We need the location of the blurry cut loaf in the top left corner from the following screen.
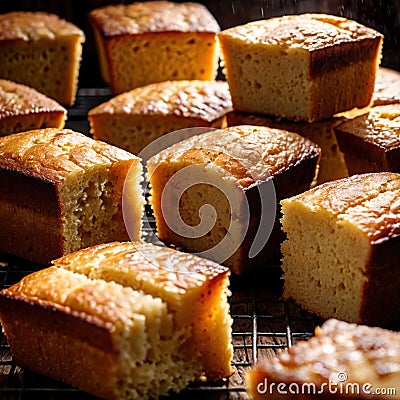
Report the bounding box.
[0,12,85,106]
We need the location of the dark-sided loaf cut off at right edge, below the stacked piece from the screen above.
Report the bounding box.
[335,103,400,174]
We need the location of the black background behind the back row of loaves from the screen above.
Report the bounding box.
[0,0,400,87]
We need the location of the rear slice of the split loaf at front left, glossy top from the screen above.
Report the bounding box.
[54,242,233,380]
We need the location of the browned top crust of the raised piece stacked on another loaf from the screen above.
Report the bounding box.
[220,14,382,51]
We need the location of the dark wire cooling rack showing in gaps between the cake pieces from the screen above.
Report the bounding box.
[0,89,322,400]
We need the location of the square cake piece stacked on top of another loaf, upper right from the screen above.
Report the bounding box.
[219,14,382,122]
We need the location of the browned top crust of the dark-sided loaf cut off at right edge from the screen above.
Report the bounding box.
[336,103,400,151]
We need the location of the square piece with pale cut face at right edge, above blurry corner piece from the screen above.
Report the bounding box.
[281,172,400,325]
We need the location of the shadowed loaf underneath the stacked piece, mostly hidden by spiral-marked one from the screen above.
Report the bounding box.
[226,111,349,185]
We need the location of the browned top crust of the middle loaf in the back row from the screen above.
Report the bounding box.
[89,1,220,37]
